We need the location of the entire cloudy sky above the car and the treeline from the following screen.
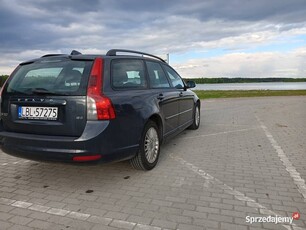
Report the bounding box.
[0,0,306,78]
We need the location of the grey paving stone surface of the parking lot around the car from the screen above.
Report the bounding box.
[0,97,306,230]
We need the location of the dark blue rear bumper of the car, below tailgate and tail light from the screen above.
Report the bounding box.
[0,121,138,162]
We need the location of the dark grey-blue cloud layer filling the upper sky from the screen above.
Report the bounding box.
[0,0,306,75]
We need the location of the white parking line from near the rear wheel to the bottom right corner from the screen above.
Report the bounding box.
[170,153,302,230]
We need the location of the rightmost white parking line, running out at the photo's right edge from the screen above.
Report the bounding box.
[255,115,306,202]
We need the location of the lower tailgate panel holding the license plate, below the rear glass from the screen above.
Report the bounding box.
[2,96,86,136]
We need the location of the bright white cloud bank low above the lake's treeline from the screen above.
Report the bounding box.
[173,48,306,78]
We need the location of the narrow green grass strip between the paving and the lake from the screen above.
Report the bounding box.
[194,90,306,99]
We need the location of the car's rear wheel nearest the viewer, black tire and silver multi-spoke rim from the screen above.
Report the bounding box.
[130,120,161,170]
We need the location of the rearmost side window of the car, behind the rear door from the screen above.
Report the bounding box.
[111,59,147,89]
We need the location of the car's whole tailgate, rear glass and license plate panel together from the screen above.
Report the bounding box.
[1,57,92,137]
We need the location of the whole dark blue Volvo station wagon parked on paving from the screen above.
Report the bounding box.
[0,49,200,170]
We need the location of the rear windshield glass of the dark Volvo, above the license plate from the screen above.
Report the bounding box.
[6,59,92,95]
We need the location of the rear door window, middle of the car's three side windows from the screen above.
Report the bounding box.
[146,61,170,88]
